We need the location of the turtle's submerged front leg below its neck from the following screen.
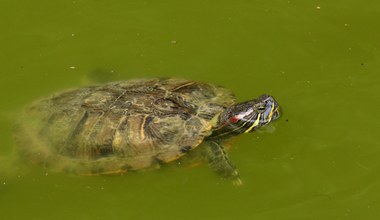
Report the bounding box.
[203,140,242,185]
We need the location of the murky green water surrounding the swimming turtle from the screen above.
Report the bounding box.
[0,0,380,220]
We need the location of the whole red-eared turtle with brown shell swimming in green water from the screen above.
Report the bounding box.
[18,78,280,184]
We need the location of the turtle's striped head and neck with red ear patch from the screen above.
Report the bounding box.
[211,94,280,137]
